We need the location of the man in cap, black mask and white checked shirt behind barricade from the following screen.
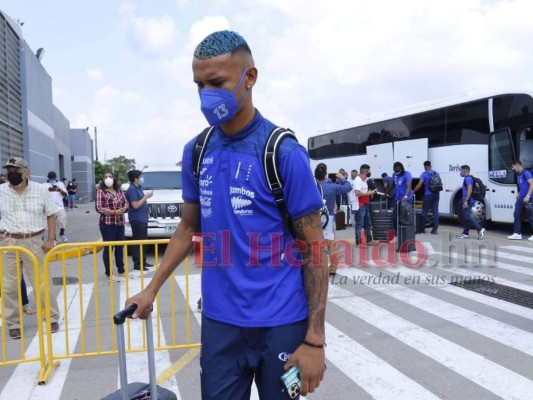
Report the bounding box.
[0,157,59,339]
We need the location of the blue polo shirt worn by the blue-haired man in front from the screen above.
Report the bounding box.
[182,111,323,327]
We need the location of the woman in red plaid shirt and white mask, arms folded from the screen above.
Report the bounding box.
[95,172,128,280]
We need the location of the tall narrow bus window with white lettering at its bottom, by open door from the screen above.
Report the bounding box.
[489,128,514,184]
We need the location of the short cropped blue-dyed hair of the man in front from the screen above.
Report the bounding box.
[194,31,252,60]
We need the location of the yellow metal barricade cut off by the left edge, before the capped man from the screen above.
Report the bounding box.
[0,246,46,376]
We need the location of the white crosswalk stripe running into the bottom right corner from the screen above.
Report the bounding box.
[330,286,533,399]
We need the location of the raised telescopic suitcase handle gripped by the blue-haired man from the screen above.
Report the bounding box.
[113,304,157,400]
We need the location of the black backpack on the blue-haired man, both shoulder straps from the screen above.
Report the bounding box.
[192,126,298,236]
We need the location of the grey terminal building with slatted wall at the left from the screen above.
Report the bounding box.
[0,10,94,202]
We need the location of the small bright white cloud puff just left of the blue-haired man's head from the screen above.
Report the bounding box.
[120,5,179,54]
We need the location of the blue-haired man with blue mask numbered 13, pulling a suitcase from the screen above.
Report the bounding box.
[127,31,328,400]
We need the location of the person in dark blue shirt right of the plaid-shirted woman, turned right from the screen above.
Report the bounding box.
[126,169,153,271]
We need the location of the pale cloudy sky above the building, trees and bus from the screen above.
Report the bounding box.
[0,0,533,168]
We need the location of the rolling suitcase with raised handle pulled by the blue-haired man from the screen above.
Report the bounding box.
[102,304,177,400]
